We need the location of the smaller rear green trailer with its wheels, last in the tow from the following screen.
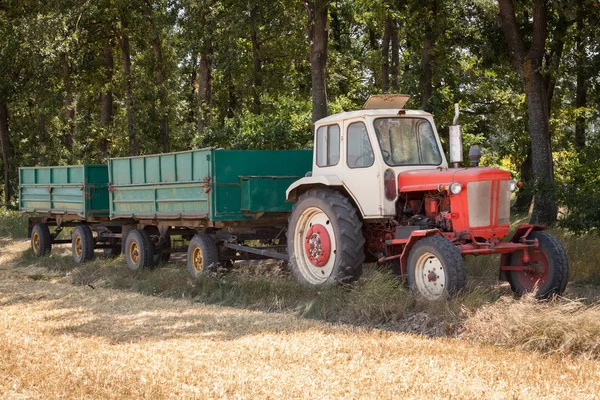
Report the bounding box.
[19,164,121,262]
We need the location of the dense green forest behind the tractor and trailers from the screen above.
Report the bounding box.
[0,0,600,232]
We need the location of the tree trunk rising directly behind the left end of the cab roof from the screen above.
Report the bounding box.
[304,0,329,122]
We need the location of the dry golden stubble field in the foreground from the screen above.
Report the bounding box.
[0,239,600,399]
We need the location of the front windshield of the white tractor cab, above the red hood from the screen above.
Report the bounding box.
[373,117,442,166]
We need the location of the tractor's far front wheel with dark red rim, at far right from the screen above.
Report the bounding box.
[507,231,569,298]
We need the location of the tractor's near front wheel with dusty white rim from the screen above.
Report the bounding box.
[407,236,467,300]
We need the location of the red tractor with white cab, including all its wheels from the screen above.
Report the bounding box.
[286,95,569,300]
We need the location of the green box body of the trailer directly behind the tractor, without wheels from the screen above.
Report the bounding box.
[108,149,312,223]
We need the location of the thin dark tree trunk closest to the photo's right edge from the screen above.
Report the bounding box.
[575,0,587,149]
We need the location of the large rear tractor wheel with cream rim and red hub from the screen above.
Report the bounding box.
[287,189,365,286]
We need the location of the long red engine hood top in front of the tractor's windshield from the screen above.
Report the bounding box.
[398,167,510,192]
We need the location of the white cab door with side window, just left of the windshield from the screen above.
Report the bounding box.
[340,119,383,218]
